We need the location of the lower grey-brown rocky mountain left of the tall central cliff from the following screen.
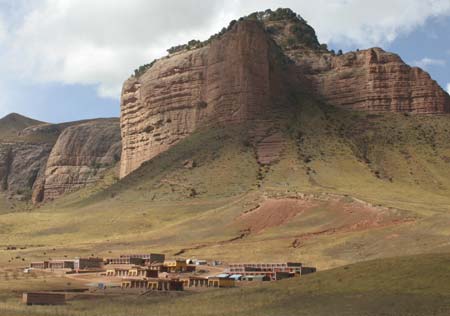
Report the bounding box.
[0,114,121,203]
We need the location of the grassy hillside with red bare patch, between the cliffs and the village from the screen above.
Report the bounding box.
[0,97,450,269]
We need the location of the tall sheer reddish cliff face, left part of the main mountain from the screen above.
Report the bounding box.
[121,21,288,177]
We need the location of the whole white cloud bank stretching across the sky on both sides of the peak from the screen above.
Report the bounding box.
[0,0,450,98]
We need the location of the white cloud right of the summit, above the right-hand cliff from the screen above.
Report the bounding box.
[234,0,450,47]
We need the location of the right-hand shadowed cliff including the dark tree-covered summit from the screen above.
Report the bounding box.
[262,11,450,114]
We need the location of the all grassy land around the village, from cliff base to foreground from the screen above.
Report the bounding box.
[0,100,450,316]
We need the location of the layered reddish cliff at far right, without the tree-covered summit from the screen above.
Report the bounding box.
[295,48,450,114]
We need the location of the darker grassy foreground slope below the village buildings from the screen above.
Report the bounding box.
[0,254,450,316]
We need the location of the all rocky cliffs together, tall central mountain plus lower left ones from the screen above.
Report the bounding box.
[0,9,450,202]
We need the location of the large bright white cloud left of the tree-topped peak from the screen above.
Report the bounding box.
[4,0,236,97]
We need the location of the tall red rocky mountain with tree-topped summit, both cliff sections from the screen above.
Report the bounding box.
[120,9,450,177]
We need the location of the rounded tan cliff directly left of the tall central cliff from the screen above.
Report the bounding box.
[38,119,121,202]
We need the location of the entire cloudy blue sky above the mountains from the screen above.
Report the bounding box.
[0,0,450,122]
